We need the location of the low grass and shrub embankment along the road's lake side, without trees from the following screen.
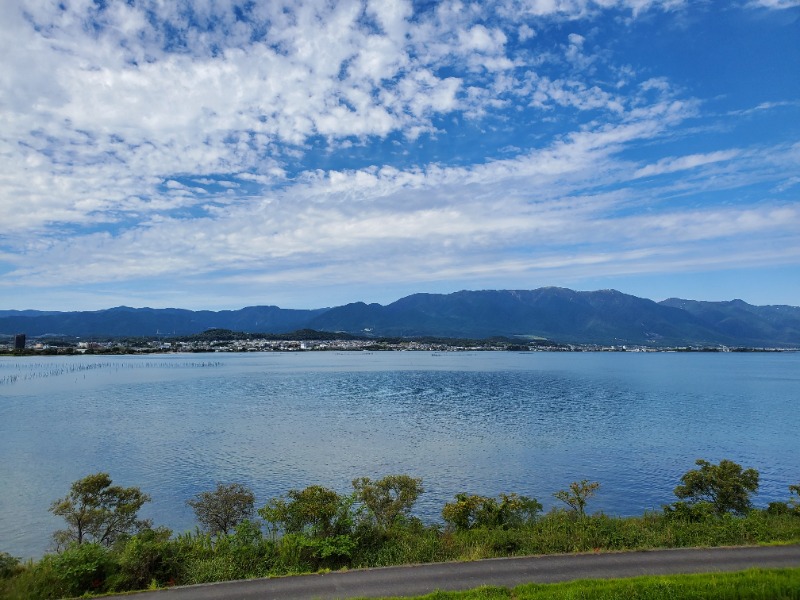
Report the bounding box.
[0,509,800,599]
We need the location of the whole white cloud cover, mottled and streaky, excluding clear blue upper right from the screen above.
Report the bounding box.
[0,0,800,310]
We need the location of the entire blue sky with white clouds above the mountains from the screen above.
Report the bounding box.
[0,0,800,310]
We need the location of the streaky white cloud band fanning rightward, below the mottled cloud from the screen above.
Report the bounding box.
[4,103,800,296]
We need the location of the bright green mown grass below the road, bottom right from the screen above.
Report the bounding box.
[366,568,800,600]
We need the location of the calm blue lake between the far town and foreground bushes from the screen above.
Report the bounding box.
[0,352,800,557]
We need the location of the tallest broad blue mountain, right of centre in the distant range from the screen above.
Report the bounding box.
[310,287,732,345]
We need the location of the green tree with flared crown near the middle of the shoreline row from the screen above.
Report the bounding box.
[353,475,425,529]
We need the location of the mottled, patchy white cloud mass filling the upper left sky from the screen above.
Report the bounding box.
[0,0,668,241]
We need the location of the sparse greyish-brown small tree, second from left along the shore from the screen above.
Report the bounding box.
[186,483,256,535]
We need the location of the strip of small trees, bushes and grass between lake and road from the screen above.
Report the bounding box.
[0,460,800,599]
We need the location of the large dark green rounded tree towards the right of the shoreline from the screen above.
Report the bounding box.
[675,459,758,514]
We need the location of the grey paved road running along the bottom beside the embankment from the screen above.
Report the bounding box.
[114,545,800,600]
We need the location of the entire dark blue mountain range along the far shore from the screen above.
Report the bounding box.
[0,287,800,347]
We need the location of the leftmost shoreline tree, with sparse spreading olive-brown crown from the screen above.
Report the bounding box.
[50,473,150,548]
